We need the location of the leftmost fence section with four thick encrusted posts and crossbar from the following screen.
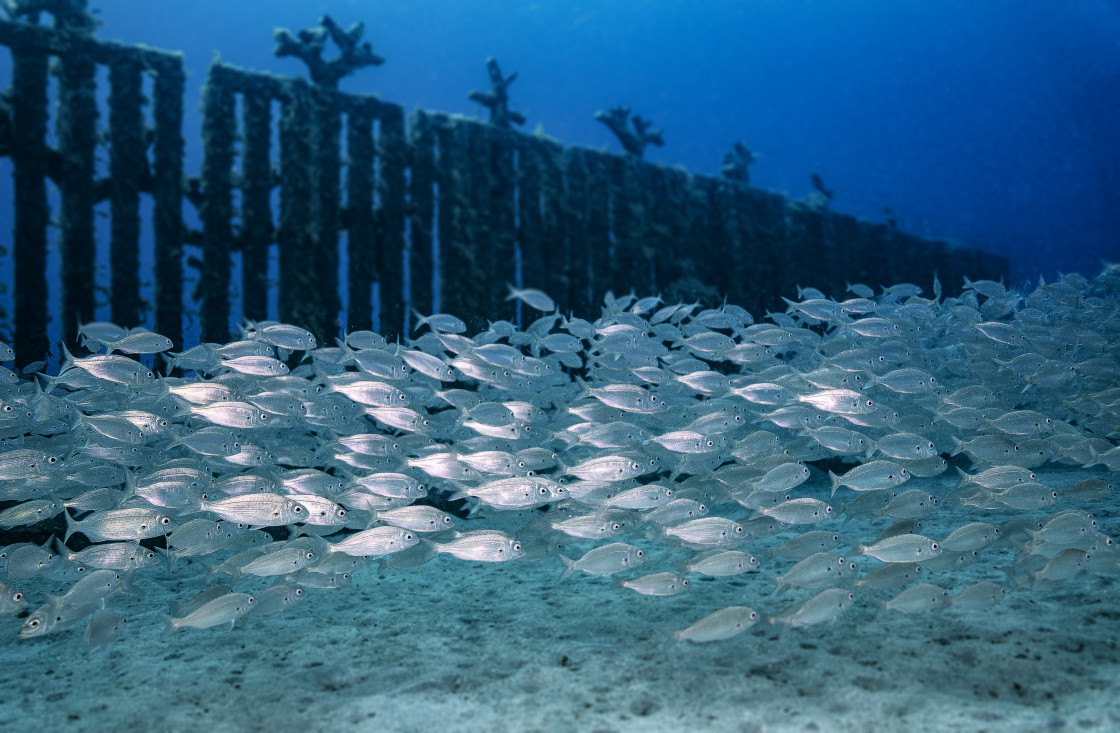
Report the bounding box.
[0,21,186,361]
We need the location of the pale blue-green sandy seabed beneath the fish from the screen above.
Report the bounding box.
[0,470,1120,733]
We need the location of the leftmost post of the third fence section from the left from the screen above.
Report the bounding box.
[409,110,436,322]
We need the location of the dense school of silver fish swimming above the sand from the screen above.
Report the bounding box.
[0,271,1120,649]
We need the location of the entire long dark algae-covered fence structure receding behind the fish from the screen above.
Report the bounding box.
[0,21,1008,363]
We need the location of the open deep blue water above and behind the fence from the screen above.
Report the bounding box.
[0,0,1120,289]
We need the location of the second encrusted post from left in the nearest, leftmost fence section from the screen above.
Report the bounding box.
[56,47,97,344]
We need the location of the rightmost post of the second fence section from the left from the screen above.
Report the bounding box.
[377,104,409,338]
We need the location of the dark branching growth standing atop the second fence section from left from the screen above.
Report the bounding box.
[272,16,385,89]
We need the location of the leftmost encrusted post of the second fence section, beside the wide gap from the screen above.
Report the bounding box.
[200,64,236,343]
